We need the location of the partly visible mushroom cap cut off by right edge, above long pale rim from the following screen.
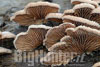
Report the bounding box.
[90,7,100,24]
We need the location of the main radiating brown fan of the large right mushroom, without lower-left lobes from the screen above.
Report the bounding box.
[60,26,100,54]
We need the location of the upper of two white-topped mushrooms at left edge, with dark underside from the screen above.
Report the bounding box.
[0,31,16,48]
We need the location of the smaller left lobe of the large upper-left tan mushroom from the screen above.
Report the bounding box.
[11,10,39,26]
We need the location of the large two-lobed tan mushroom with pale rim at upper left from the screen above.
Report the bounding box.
[11,2,60,26]
